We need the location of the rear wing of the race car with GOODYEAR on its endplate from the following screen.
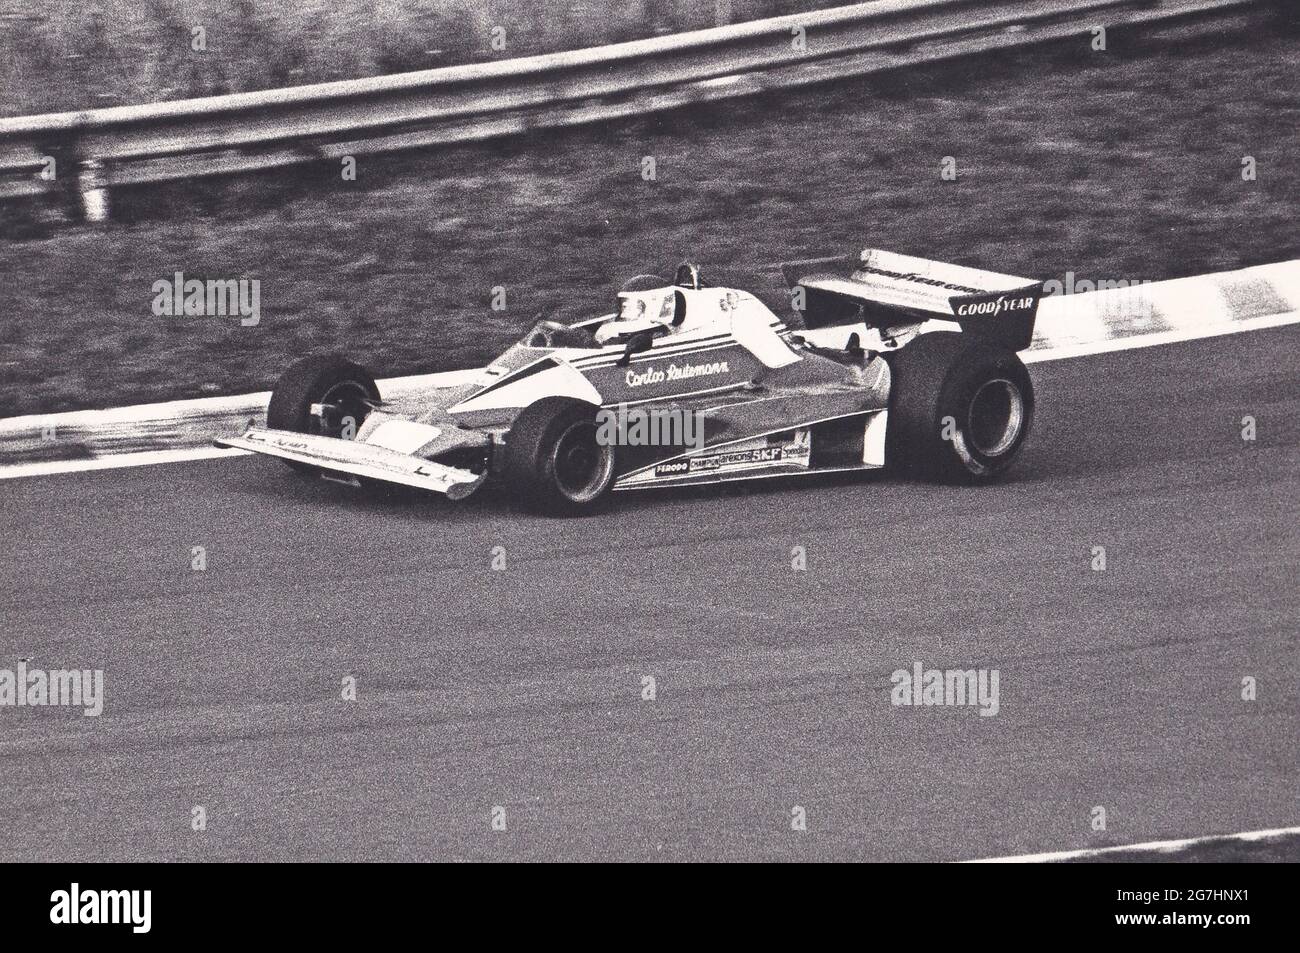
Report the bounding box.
[781,248,1043,351]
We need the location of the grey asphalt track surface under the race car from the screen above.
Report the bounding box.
[0,328,1300,861]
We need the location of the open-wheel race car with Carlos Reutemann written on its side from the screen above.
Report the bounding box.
[215,250,1043,514]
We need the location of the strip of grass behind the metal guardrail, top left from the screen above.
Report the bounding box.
[0,0,840,116]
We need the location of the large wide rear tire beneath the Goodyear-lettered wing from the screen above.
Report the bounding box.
[885,332,1034,484]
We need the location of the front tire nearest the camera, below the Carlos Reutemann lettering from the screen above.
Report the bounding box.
[501,397,615,516]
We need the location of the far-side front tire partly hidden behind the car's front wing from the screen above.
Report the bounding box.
[267,354,380,473]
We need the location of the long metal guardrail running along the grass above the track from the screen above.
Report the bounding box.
[0,0,1261,220]
